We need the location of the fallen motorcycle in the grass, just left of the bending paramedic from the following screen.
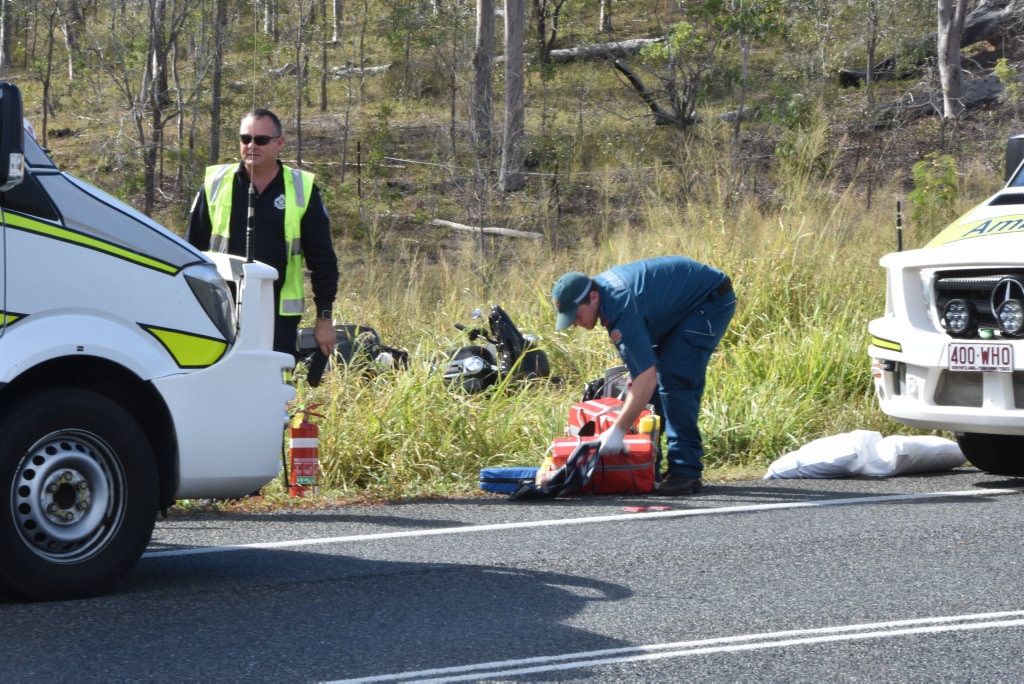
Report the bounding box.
[435,304,557,393]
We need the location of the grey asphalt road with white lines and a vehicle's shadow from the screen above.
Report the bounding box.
[0,468,1024,682]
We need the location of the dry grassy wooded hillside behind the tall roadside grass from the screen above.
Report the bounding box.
[8,0,1021,250]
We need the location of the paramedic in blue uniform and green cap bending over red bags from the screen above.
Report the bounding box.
[551,257,736,496]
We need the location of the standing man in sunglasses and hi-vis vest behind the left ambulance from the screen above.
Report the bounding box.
[185,110,338,356]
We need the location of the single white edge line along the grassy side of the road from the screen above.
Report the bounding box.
[142,487,1024,558]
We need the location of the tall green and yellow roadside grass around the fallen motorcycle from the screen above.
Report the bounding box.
[258,167,921,501]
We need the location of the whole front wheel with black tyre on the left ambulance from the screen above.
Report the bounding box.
[0,388,158,600]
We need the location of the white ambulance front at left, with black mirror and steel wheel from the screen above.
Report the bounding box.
[0,83,295,600]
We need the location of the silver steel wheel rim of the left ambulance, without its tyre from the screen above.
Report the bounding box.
[10,430,125,563]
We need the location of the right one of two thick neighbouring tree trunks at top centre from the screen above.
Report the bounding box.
[498,0,526,193]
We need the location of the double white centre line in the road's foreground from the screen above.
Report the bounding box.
[335,610,1024,684]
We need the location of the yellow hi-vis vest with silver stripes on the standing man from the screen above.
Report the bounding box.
[199,164,313,315]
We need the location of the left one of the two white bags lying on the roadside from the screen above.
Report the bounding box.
[764,430,882,480]
